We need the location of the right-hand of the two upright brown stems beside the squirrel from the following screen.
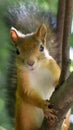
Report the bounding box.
[60,0,73,84]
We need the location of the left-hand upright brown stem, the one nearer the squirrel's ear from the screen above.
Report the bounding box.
[56,0,66,66]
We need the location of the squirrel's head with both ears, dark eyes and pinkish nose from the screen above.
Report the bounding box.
[10,24,48,70]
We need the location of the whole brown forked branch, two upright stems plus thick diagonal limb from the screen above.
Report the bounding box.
[42,0,73,130]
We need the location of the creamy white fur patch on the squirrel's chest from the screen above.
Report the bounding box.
[29,68,55,100]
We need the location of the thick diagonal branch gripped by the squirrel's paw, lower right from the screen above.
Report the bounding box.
[48,72,73,130]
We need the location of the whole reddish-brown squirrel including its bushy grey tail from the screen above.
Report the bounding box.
[6,1,70,130]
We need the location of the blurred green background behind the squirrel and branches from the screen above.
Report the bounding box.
[0,0,73,130]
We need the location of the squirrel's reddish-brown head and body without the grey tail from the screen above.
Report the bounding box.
[10,24,60,130]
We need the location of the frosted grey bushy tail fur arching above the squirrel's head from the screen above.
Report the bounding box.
[5,2,56,33]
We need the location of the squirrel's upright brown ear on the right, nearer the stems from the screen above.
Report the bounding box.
[36,24,47,41]
